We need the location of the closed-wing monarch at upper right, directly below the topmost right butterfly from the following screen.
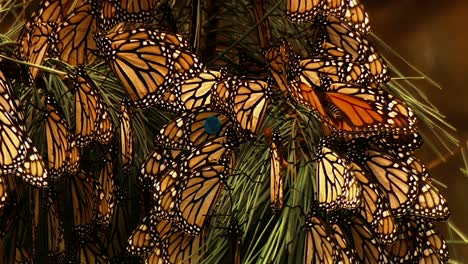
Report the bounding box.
[314,15,390,83]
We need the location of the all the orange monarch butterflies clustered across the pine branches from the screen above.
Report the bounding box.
[0,0,449,263]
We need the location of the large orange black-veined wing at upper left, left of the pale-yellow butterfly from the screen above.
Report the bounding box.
[96,28,174,107]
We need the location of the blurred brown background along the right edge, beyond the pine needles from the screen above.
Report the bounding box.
[363,0,468,263]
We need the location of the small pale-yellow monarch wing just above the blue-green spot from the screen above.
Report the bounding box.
[158,71,221,113]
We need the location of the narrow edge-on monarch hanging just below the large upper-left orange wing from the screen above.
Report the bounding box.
[119,99,134,172]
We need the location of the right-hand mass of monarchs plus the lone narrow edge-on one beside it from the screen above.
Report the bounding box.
[264,0,450,263]
